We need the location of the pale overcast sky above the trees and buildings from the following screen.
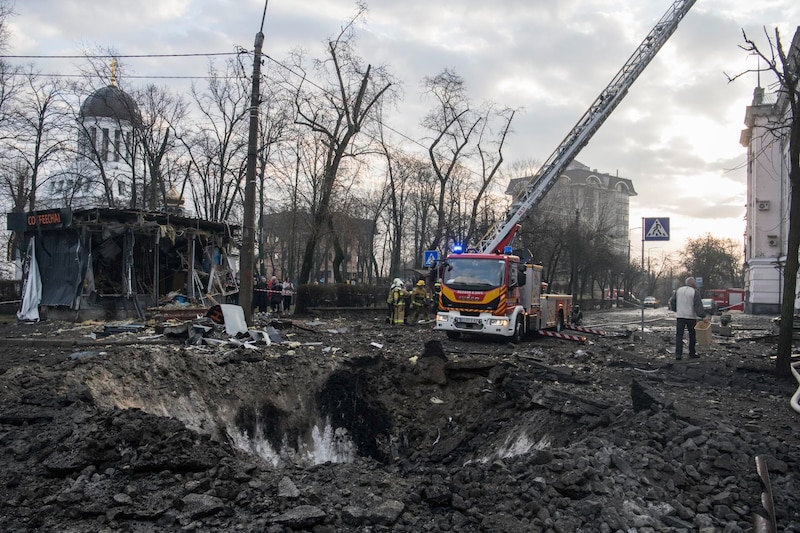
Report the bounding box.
[7,0,800,256]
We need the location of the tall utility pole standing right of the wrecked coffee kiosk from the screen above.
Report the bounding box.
[239,0,269,326]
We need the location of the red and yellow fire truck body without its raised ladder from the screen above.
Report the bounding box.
[434,253,572,342]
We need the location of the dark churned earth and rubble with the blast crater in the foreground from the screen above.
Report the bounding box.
[0,313,800,533]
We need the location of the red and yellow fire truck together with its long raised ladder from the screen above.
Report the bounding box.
[434,0,696,340]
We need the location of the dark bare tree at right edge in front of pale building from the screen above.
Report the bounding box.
[728,27,800,377]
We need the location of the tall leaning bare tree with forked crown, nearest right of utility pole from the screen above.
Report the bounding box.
[295,6,392,283]
